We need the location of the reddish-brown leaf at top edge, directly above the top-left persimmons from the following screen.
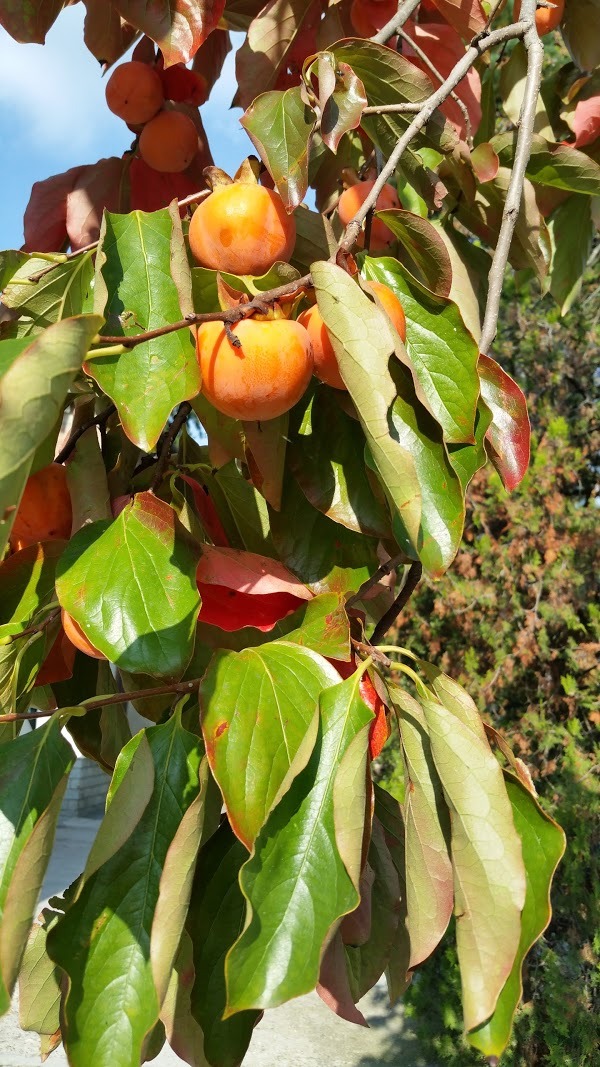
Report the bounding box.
[113,0,225,66]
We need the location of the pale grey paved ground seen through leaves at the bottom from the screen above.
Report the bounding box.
[0,818,432,1067]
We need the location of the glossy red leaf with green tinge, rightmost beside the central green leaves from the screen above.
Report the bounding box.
[477,355,531,492]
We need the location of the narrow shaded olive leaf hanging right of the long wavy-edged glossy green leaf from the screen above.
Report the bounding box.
[345,818,400,1003]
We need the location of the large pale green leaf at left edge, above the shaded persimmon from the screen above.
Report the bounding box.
[0,315,102,553]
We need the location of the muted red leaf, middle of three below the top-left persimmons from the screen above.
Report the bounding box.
[66,156,130,250]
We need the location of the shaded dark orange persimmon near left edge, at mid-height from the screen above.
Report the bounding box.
[10,463,73,552]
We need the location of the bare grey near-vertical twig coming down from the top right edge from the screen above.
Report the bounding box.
[479,0,543,354]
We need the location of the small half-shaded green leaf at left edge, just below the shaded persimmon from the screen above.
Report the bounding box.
[0,541,64,635]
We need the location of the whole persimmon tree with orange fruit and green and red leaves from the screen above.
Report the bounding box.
[0,0,600,1067]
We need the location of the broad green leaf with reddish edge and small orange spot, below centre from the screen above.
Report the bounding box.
[200,641,340,849]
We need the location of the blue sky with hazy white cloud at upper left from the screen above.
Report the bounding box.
[0,4,248,249]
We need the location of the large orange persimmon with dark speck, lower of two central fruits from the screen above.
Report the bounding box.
[198,319,313,421]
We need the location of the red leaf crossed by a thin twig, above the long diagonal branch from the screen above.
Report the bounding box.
[404,21,481,137]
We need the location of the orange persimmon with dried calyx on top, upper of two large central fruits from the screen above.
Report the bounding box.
[190,181,296,275]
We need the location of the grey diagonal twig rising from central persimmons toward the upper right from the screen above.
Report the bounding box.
[340,21,533,252]
